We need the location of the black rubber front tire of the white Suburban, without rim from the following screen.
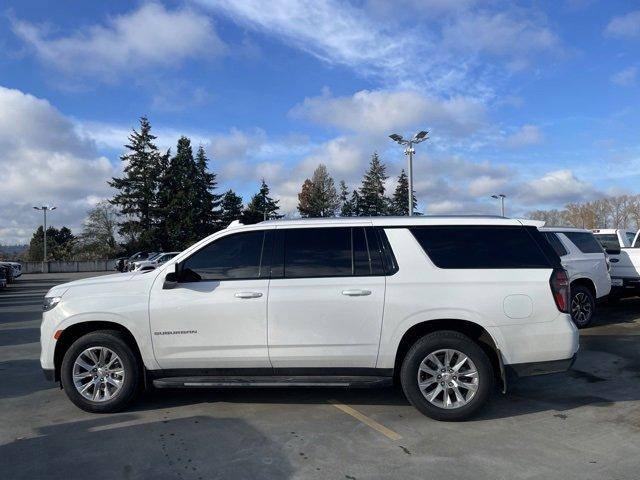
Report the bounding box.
[60,330,141,413]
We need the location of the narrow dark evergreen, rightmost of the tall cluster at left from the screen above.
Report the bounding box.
[193,145,221,238]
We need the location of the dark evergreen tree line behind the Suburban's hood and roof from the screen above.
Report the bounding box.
[25,117,417,261]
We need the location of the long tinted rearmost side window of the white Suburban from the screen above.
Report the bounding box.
[410,225,553,269]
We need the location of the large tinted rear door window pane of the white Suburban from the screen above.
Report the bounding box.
[284,228,353,278]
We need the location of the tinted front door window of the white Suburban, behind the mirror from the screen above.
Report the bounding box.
[181,231,266,281]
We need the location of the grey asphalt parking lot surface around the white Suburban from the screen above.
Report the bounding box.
[0,274,640,480]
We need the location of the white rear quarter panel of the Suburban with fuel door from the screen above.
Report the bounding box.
[378,228,567,368]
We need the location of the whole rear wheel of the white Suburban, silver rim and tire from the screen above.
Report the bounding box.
[400,331,494,421]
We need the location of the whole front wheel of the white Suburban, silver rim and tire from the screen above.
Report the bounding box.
[60,330,140,413]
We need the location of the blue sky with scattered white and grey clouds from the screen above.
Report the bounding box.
[0,0,640,244]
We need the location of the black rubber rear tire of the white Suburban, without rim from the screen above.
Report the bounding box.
[400,330,494,421]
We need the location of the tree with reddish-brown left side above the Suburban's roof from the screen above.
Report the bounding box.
[298,164,340,217]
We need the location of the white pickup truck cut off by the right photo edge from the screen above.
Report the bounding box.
[593,228,640,300]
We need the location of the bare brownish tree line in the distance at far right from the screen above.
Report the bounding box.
[527,195,640,230]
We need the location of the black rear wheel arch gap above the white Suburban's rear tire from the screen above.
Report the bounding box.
[393,318,506,391]
